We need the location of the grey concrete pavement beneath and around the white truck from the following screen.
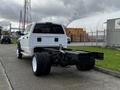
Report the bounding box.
[0,45,120,90]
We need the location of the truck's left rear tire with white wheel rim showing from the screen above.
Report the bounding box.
[32,52,51,76]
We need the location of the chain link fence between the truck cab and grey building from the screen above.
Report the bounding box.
[70,30,106,46]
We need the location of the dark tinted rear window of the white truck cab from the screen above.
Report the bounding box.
[33,24,64,34]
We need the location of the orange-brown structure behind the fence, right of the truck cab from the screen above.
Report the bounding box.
[65,28,89,42]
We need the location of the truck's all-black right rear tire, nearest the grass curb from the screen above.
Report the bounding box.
[76,58,95,71]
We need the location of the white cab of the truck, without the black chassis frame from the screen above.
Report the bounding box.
[18,23,67,56]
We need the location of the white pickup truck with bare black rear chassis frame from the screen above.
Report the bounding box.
[17,23,103,76]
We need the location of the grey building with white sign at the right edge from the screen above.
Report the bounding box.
[106,18,120,47]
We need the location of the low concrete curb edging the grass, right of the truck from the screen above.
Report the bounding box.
[94,66,120,78]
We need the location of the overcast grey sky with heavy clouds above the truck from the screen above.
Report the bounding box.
[0,0,120,25]
